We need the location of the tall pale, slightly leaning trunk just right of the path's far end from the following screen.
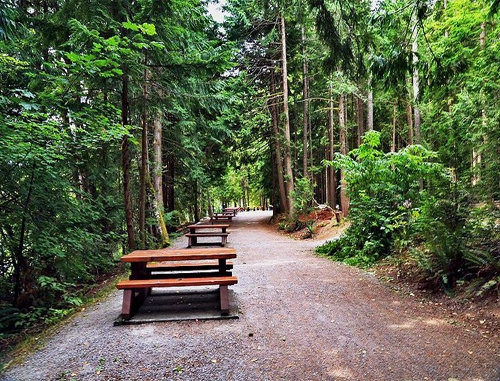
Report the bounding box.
[280,14,295,218]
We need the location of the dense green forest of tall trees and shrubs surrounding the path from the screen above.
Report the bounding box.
[0,0,500,338]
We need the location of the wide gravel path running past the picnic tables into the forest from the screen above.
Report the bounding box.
[0,212,500,381]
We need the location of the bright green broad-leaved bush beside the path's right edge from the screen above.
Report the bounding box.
[318,132,443,265]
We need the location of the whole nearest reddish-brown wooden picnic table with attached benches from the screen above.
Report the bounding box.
[116,248,238,319]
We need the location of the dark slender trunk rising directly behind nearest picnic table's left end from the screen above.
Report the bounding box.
[121,68,136,250]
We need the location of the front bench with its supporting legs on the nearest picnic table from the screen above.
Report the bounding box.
[116,276,238,319]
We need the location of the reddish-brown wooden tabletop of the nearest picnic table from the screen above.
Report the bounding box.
[120,247,236,262]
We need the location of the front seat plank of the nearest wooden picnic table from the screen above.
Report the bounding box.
[116,276,238,290]
